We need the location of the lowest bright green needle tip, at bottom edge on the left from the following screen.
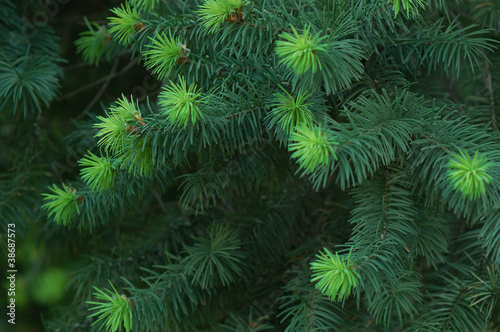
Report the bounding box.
[85,281,133,332]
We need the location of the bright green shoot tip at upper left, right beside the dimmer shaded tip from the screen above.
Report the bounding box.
[108,4,143,45]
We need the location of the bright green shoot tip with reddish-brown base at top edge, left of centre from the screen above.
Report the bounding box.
[198,0,246,33]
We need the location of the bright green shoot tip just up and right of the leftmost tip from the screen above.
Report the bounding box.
[78,151,116,192]
